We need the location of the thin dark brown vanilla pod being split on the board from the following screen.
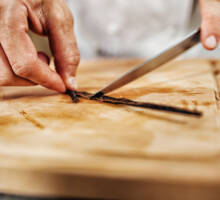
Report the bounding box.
[67,91,202,117]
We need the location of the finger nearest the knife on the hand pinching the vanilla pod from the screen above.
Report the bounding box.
[47,4,80,90]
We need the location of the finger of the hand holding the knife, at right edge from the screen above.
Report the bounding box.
[200,0,220,50]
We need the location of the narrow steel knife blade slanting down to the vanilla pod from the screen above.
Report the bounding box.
[91,29,201,99]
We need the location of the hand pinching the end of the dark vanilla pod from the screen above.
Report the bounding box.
[0,0,80,92]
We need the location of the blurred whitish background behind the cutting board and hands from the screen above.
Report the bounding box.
[30,0,220,59]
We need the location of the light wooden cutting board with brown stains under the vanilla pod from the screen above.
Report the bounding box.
[0,60,220,200]
